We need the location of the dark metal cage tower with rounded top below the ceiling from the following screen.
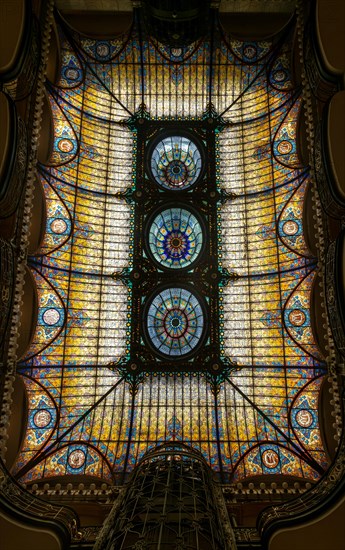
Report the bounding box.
[96,442,235,550]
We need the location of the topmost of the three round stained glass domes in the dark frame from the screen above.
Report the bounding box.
[150,135,202,191]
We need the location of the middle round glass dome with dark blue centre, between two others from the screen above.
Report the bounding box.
[148,207,204,269]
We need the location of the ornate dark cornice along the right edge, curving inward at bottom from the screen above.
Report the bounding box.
[257,0,345,546]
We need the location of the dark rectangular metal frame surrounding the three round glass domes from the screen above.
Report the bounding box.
[114,112,233,380]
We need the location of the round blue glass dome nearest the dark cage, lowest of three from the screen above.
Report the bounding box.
[146,287,205,358]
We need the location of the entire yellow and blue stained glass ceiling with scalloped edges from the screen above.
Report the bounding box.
[14,12,328,483]
